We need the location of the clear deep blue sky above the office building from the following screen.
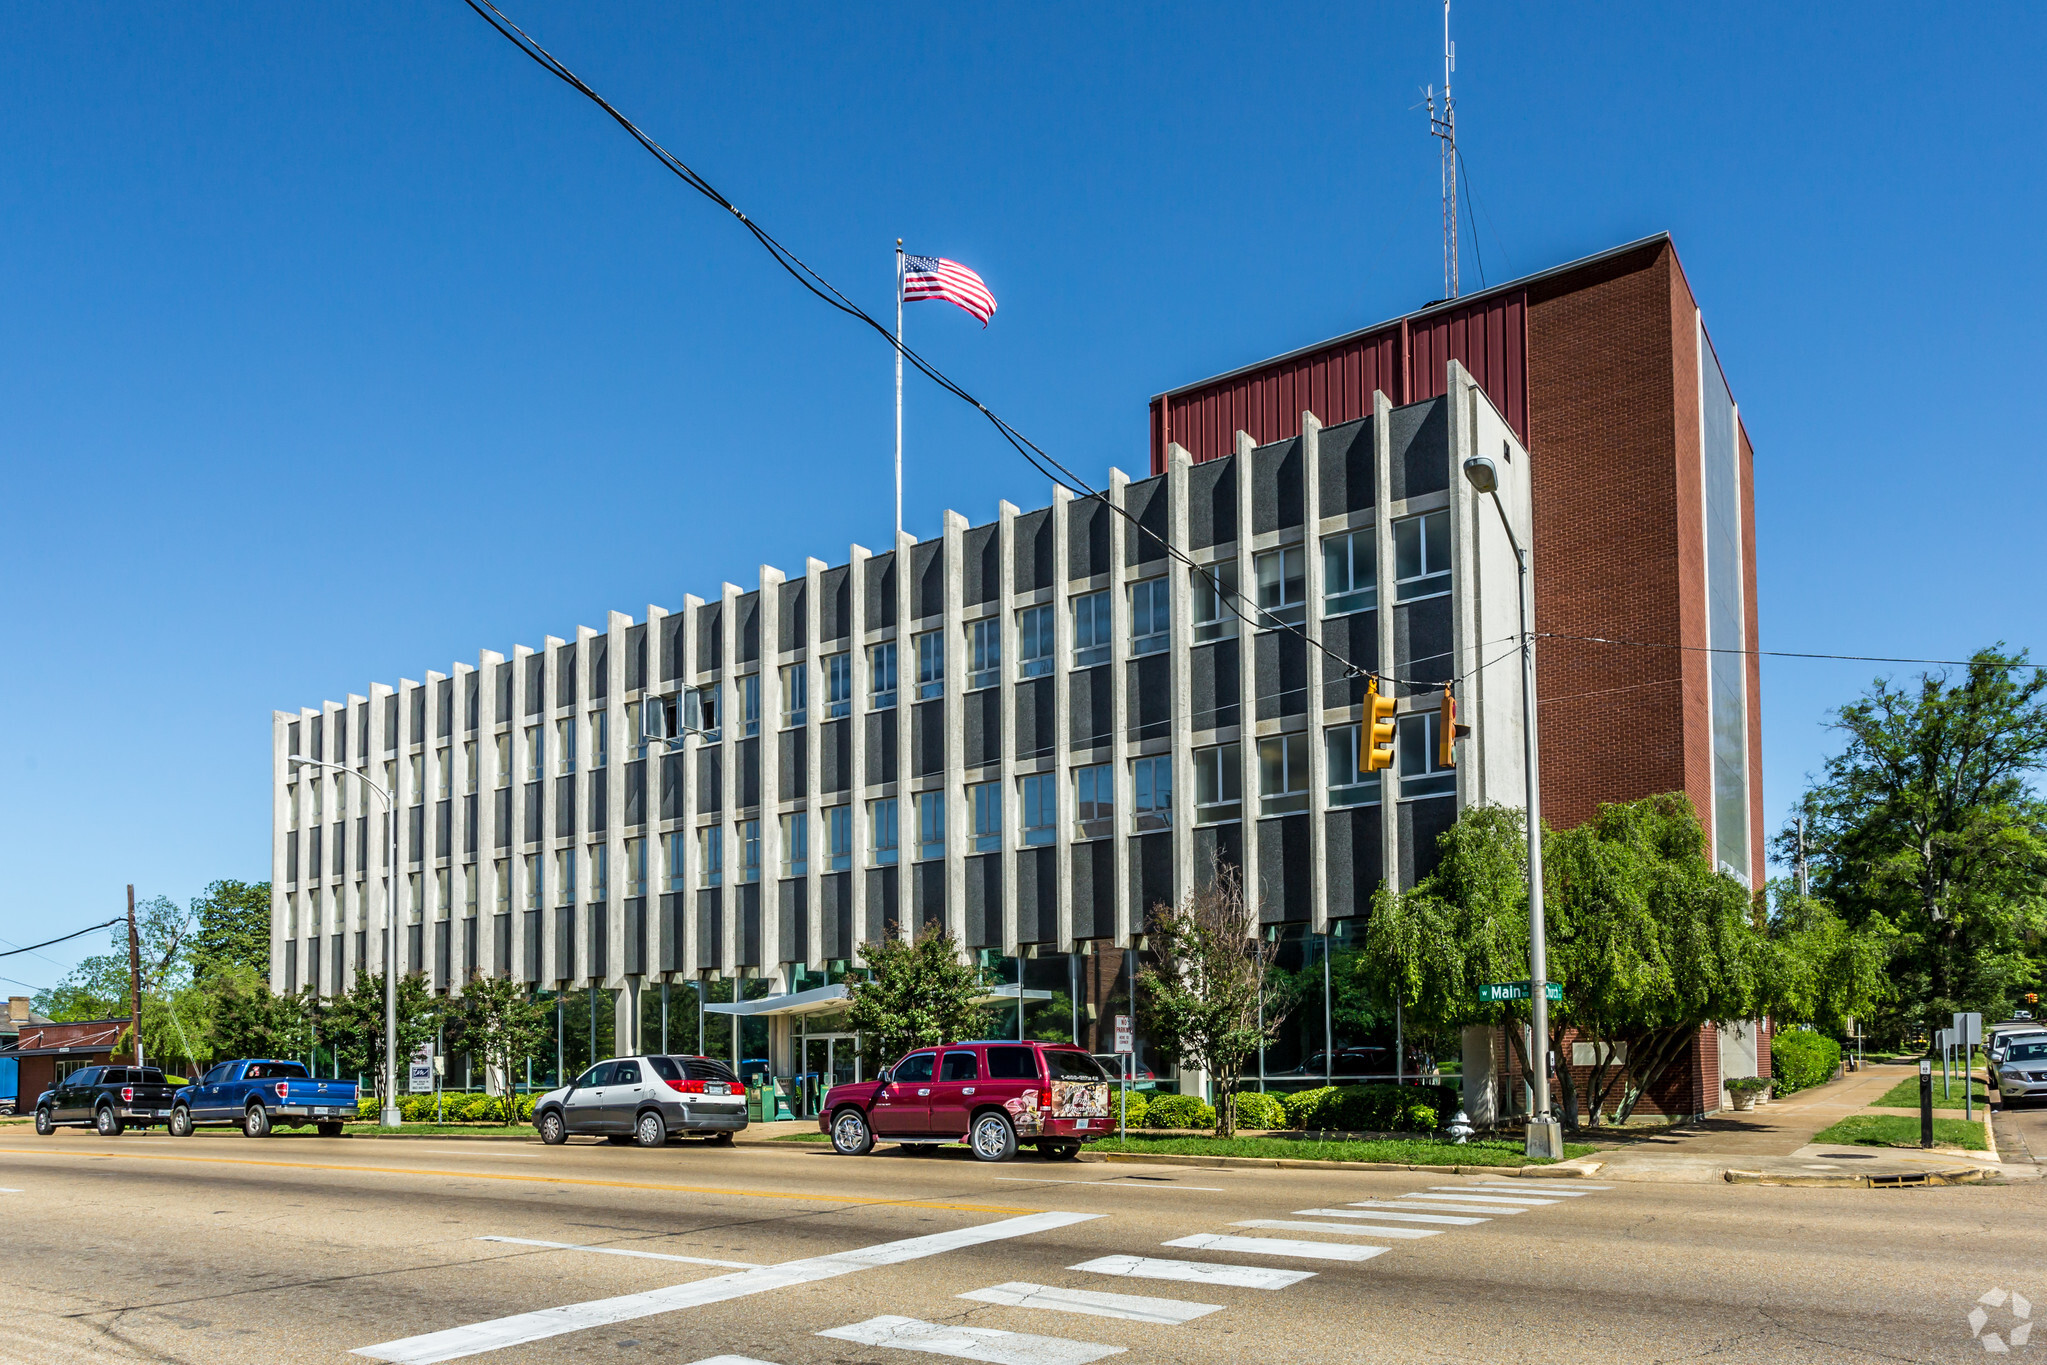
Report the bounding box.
[0,0,2047,993]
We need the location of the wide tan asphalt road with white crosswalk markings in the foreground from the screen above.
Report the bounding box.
[0,1128,2047,1365]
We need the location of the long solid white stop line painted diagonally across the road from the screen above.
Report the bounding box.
[354,1214,1101,1365]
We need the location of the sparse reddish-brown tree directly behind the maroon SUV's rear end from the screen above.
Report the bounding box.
[1138,860,1306,1138]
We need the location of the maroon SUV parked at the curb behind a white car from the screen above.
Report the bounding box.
[817,1042,1114,1160]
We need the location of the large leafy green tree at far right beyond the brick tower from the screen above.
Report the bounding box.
[1777,645,2047,1038]
